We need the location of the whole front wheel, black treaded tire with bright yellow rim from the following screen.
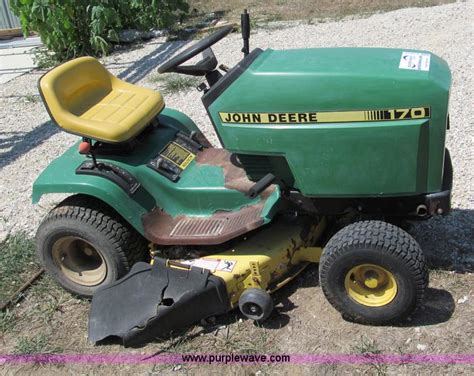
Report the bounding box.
[319,221,428,325]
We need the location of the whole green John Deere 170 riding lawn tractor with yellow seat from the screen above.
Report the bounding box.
[33,13,452,346]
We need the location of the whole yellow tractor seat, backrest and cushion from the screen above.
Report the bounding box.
[39,57,165,143]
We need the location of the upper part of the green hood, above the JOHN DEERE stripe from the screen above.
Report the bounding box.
[213,48,451,112]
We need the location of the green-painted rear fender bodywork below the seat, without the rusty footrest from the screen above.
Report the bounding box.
[32,108,274,235]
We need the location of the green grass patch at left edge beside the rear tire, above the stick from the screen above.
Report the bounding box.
[0,233,39,302]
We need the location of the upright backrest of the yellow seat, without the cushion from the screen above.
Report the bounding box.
[38,56,112,119]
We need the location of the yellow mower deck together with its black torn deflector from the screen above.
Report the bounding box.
[89,217,325,346]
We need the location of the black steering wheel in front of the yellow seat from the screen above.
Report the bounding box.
[158,25,234,76]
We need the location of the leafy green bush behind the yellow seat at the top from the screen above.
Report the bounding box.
[10,0,188,61]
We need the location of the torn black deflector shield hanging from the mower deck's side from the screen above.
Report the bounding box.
[89,259,229,347]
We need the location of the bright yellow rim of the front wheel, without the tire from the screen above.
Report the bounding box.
[344,264,398,307]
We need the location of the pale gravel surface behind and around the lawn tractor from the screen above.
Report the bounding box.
[0,1,474,269]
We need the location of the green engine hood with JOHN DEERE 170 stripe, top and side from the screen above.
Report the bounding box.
[208,48,451,197]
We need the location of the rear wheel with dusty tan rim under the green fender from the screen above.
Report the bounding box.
[36,195,146,297]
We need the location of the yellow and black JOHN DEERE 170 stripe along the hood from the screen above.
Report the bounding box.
[219,107,431,124]
